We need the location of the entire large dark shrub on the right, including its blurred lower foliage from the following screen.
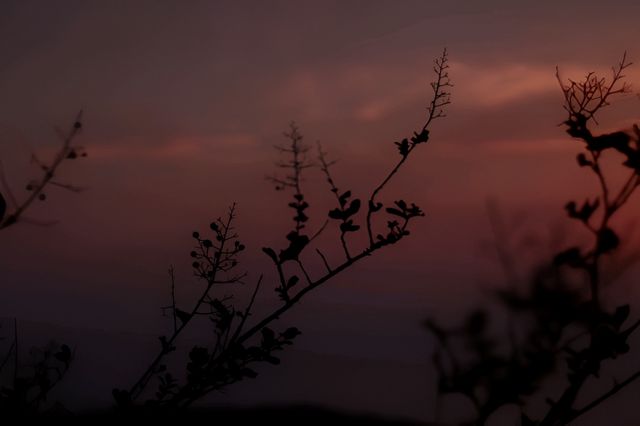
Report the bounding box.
[425,54,640,426]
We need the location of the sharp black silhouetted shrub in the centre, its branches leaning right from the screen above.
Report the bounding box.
[113,50,451,409]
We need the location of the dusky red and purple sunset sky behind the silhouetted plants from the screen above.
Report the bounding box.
[0,0,640,420]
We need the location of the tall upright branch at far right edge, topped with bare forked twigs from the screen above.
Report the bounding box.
[540,53,640,426]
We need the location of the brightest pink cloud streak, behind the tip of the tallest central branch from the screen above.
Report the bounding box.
[273,56,640,122]
